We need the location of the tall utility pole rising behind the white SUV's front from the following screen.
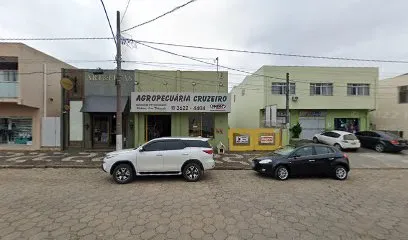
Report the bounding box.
[115,11,123,150]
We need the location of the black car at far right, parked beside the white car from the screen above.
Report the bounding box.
[356,131,408,152]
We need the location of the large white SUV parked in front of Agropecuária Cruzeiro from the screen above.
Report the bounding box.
[102,137,215,184]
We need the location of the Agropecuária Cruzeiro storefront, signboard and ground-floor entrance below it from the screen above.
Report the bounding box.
[130,92,231,147]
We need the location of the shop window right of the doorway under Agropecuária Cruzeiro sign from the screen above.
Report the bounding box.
[188,113,214,138]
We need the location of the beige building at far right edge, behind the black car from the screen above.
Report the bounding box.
[371,74,408,138]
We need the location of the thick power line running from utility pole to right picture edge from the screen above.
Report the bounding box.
[127,39,408,64]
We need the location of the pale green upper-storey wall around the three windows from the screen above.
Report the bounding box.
[262,66,378,109]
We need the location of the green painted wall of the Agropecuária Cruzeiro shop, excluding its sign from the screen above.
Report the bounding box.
[134,70,228,147]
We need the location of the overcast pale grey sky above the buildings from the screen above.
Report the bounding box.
[0,0,408,87]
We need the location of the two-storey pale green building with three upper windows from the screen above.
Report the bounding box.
[229,66,378,139]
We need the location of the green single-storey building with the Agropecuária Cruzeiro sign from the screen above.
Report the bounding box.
[129,70,231,149]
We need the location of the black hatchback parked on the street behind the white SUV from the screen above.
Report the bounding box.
[252,144,350,180]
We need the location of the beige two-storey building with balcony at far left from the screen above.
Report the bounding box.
[0,43,73,150]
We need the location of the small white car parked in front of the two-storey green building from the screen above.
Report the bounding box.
[313,131,361,150]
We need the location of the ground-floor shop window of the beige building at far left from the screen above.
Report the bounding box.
[0,117,33,145]
